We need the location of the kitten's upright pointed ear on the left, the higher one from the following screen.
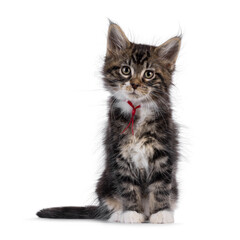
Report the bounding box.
[107,21,130,55]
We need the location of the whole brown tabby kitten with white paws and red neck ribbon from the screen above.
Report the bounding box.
[37,23,181,223]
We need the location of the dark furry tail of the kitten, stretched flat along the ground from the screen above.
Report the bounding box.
[37,206,111,219]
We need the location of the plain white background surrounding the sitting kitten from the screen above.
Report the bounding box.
[0,0,240,240]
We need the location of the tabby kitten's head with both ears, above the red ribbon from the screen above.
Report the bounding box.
[103,22,181,102]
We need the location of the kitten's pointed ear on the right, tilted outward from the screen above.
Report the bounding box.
[156,37,181,71]
